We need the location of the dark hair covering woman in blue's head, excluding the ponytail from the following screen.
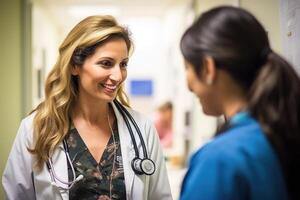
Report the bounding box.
[181,7,270,89]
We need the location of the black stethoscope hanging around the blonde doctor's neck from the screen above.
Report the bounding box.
[46,99,156,190]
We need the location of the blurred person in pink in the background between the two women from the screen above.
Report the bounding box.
[154,101,173,148]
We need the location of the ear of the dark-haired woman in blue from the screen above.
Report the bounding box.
[202,56,217,85]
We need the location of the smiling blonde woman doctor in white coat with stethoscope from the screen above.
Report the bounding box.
[2,16,172,200]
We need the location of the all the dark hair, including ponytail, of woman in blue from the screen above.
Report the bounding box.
[181,7,300,199]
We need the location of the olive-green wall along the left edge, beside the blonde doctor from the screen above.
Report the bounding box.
[0,0,22,199]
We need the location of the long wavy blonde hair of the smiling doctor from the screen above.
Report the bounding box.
[28,16,132,169]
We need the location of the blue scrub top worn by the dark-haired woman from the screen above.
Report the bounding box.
[180,112,288,200]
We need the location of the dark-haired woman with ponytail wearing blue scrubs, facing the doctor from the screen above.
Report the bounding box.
[180,6,300,200]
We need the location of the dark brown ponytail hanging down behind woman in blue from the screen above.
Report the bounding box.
[248,52,300,199]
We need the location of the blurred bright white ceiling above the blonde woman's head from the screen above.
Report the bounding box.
[32,0,191,35]
